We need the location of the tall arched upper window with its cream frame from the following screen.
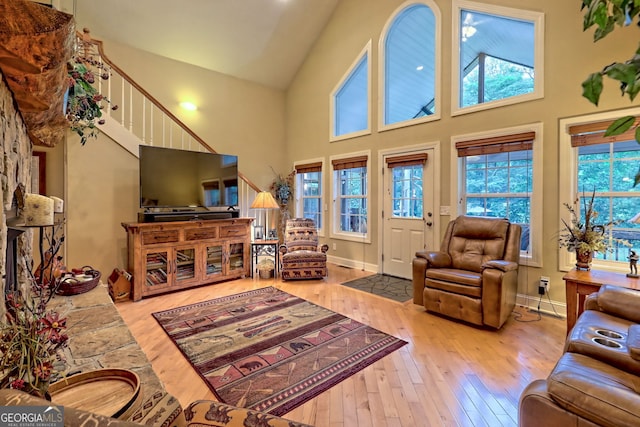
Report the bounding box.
[380,2,440,129]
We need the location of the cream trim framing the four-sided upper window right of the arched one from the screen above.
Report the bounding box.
[451,0,544,116]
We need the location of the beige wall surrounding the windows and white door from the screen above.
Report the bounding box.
[286,0,638,301]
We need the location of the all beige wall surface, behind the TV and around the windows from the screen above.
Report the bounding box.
[56,0,637,301]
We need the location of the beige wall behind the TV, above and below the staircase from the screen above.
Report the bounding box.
[61,41,288,280]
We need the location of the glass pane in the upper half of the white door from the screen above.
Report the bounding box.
[391,165,424,218]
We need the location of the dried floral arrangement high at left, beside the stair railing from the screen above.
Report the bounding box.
[66,28,118,145]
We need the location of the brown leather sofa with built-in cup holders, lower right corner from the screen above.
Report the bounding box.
[519,285,640,427]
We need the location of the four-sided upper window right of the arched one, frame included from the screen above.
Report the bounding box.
[453,0,543,114]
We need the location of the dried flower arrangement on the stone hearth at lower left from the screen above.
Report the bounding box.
[0,226,68,398]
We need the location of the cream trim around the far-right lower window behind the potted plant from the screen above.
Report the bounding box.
[554,107,640,273]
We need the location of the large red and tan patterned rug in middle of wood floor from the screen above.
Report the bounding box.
[153,287,406,416]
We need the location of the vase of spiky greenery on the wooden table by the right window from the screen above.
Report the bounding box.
[559,191,631,270]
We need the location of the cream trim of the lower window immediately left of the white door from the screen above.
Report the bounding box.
[325,150,373,243]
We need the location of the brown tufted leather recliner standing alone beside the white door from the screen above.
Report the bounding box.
[413,216,522,329]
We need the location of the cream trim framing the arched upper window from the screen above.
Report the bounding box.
[378,0,442,132]
